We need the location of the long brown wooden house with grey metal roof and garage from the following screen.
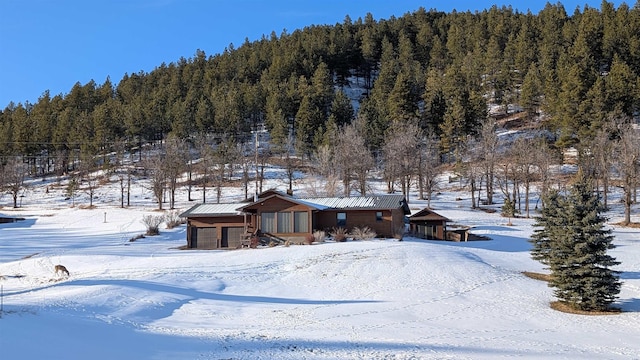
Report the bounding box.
[180,190,410,249]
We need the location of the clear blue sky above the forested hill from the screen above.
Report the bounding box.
[0,0,620,109]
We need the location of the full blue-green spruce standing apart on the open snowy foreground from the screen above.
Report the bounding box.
[532,178,620,311]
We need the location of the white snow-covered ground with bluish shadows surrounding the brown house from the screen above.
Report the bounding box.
[0,169,640,360]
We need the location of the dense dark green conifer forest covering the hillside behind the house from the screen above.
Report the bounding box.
[0,1,640,217]
